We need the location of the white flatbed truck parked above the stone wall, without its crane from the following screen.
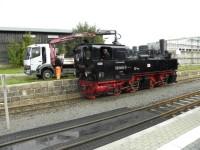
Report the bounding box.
[24,44,74,79]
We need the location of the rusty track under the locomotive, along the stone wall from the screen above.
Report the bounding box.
[0,76,200,116]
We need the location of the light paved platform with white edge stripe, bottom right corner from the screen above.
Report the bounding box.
[96,107,200,150]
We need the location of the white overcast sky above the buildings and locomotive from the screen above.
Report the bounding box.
[0,0,200,46]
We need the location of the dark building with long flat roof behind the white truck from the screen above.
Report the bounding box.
[0,27,72,64]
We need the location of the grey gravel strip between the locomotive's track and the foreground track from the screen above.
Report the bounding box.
[0,80,200,135]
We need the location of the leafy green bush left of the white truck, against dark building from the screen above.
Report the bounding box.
[8,33,34,66]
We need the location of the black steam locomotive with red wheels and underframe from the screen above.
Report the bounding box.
[74,30,178,99]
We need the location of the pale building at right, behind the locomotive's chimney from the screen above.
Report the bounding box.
[148,37,200,64]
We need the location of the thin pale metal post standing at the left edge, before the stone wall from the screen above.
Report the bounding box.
[1,75,10,129]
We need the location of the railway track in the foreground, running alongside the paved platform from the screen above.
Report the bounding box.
[0,90,200,150]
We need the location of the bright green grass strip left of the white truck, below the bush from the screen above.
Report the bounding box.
[0,67,24,74]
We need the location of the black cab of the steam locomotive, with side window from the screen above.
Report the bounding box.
[74,44,128,81]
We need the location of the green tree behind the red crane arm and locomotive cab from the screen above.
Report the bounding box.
[59,22,104,57]
